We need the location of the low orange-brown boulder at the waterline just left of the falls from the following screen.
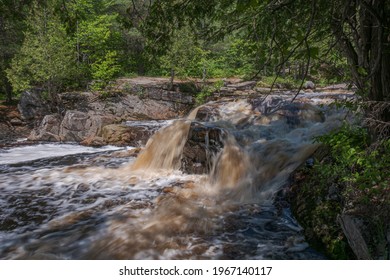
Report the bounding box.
[103,124,154,147]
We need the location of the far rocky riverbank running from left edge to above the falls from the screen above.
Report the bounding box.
[3,77,352,146]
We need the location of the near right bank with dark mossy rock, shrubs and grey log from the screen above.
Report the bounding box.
[290,125,390,259]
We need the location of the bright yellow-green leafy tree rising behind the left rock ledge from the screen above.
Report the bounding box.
[60,0,121,85]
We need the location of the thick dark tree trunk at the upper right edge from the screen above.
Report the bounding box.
[332,0,390,101]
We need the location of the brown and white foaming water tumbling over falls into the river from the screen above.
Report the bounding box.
[0,92,350,259]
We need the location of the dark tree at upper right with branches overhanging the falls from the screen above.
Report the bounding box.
[140,0,390,106]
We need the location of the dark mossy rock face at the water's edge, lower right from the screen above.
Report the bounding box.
[292,160,353,259]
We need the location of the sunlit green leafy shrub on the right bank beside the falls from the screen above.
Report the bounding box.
[319,126,390,204]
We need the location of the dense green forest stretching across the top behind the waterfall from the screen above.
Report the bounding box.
[0,0,390,104]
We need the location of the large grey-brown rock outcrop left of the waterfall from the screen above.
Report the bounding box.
[26,79,194,146]
